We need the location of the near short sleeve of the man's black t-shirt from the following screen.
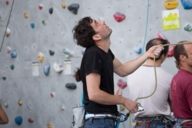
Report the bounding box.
[84,52,102,75]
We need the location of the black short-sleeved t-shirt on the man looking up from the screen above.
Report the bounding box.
[80,46,117,114]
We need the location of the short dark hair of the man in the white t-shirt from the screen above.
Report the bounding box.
[146,38,169,60]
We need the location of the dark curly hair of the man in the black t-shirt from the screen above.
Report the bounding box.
[73,17,96,48]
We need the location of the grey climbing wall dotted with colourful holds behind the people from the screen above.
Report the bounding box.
[0,0,192,128]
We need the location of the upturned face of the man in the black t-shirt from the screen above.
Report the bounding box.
[91,20,112,39]
